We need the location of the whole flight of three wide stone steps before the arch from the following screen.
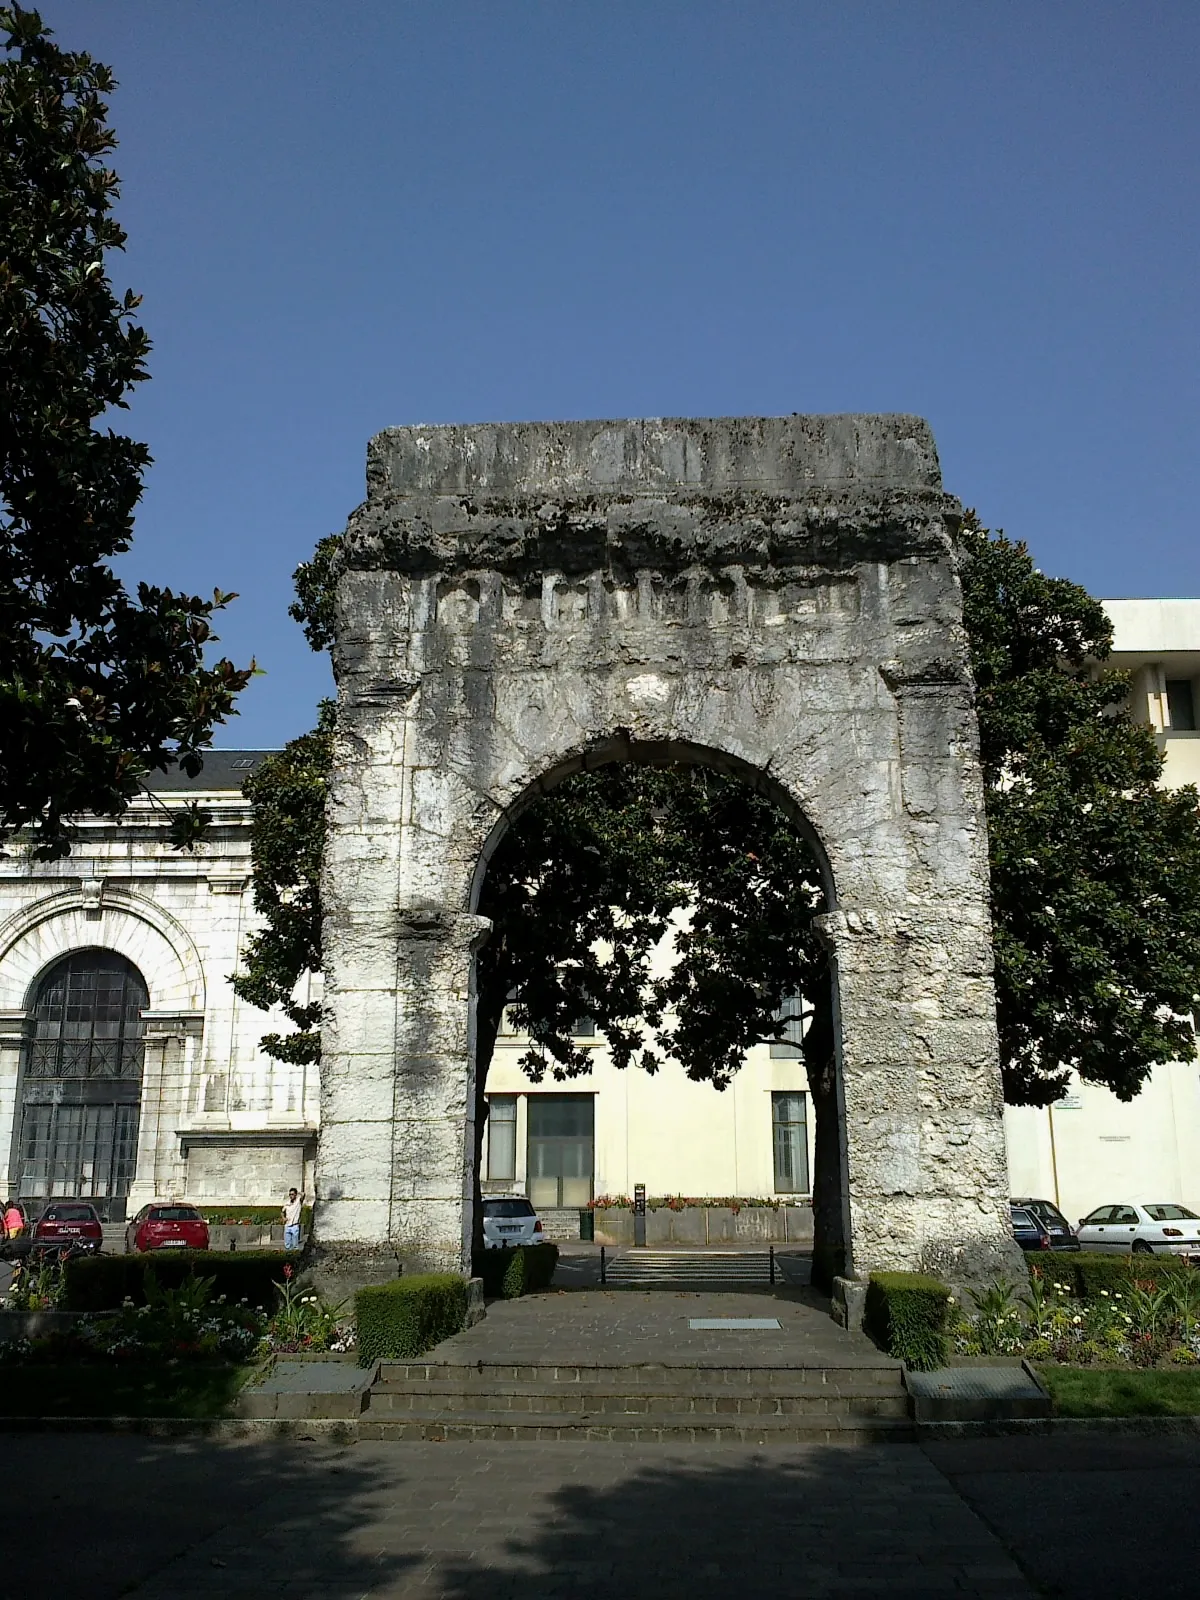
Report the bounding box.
[358,1362,914,1445]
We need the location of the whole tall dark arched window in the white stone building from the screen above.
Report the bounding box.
[13,949,150,1221]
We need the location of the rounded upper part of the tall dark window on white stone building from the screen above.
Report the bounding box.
[26,950,150,1078]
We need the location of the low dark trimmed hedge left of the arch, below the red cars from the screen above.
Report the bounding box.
[66,1250,296,1310]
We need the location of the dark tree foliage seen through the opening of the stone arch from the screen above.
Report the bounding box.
[478,766,824,1088]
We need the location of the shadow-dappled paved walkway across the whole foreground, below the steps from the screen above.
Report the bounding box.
[0,1434,1200,1600]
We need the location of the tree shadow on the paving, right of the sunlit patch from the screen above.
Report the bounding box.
[432,1446,1032,1600]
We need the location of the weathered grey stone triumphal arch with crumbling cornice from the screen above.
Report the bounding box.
[317,416,1013,1277]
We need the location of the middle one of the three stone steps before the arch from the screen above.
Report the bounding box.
[370,1384,909,1419]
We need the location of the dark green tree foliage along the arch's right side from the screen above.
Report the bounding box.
[962,514,1200,1106]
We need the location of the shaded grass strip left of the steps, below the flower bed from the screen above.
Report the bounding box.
[0,1362,254,1418]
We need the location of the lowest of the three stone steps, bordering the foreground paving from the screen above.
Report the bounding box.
[358,1410,915,1445]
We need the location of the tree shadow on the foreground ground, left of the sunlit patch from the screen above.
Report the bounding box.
[0,1432,421,1600]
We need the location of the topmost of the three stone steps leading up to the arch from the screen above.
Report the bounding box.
[373,1360,904,1394]
